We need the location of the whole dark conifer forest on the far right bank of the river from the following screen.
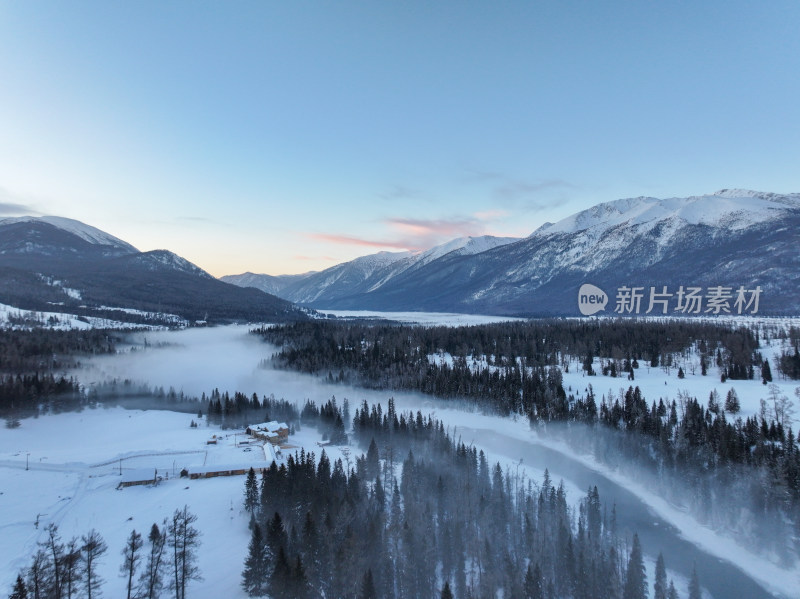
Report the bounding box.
[255,320,800,564]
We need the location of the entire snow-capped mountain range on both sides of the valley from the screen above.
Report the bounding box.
[0,190,800,322]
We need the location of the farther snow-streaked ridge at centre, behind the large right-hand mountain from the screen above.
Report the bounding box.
[222,235,518,305]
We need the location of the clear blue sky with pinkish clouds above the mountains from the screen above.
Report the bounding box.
[0,0,800,275]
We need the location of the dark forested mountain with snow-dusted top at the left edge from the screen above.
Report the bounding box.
[0,216,306,322]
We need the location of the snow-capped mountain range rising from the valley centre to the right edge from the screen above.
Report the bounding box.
[222,189,800,316]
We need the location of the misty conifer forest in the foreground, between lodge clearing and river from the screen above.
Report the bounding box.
[242,398,699,599]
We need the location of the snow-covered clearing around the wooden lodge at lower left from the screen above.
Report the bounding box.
[0,408,362,599]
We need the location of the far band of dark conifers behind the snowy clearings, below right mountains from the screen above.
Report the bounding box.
[254,319,764,383]
